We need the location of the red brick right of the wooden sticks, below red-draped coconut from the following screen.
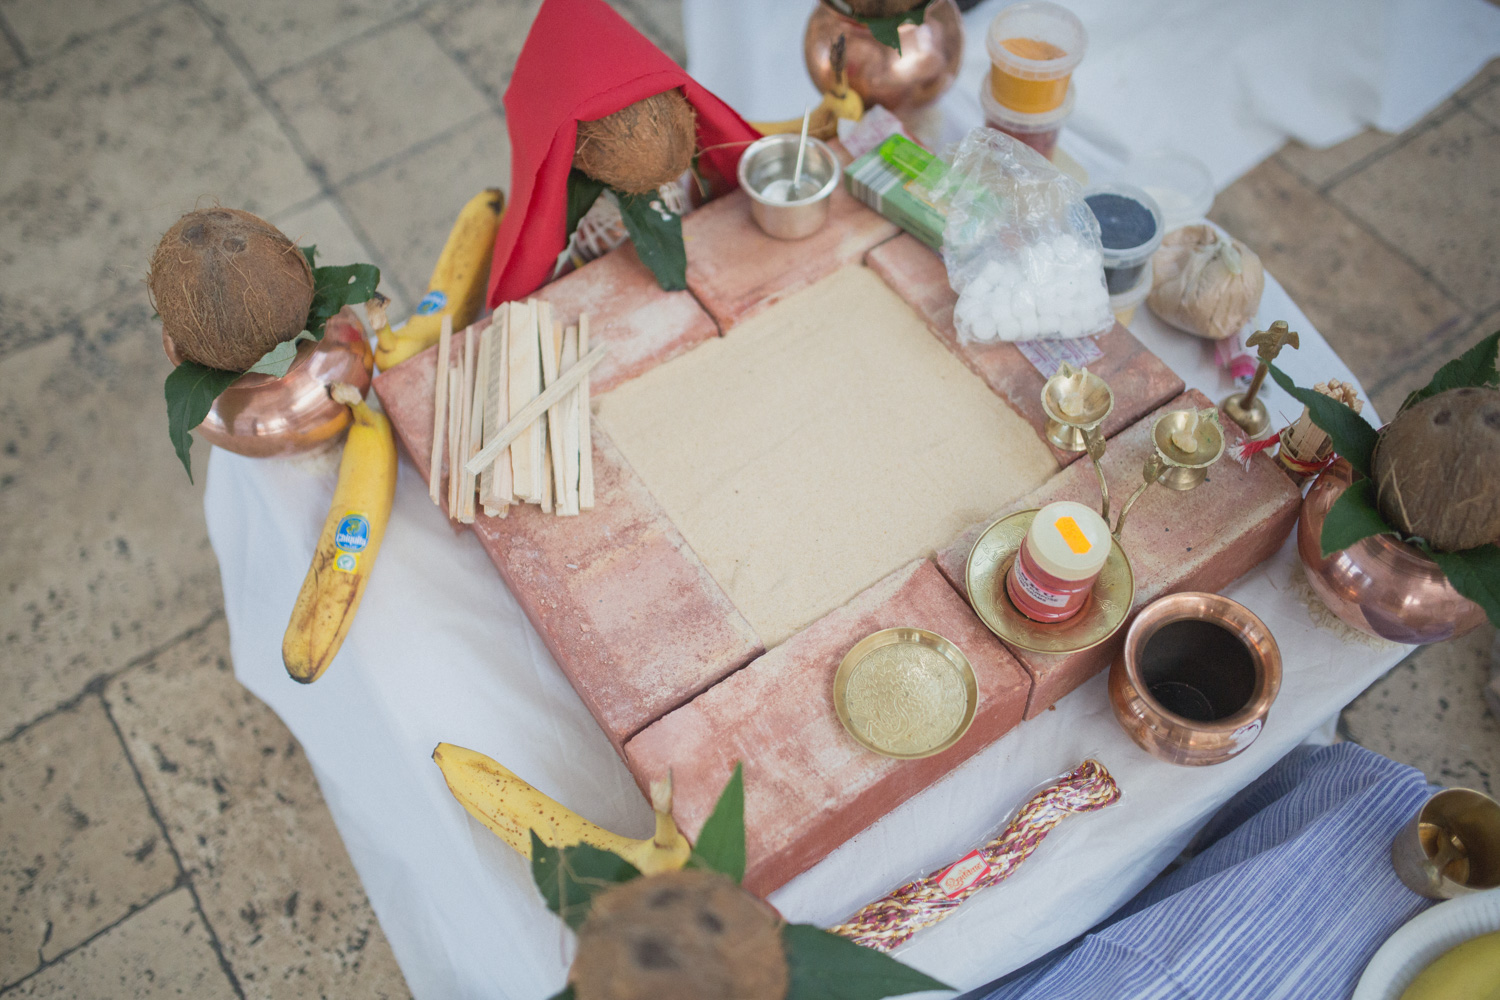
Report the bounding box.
[537,241,719,396]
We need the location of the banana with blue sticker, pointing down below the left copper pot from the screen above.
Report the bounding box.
[282,382,396,684]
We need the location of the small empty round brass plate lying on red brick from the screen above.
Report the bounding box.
[834,628,980,760]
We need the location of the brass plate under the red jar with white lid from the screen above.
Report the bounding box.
[965,508,1136,652]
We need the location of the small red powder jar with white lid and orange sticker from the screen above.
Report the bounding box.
[1005,501,1113,622]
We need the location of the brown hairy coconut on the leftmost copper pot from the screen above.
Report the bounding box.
[146,208,314,372]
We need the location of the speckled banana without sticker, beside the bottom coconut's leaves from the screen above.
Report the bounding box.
[432,744,693,876]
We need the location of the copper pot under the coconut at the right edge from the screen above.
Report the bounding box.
[1298,459,1485,645]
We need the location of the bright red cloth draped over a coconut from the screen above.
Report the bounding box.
[489,0,761,307]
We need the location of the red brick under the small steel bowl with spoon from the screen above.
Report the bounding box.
[683,186,899,333]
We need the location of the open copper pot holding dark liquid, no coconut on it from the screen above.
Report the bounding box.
[1110,591,1281,765]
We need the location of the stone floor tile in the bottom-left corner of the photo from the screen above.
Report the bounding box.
[6,889,236,1000]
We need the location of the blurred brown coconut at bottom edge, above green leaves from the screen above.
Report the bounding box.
[569,868,788,1000]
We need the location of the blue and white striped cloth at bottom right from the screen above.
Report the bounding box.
[971,744,1431,1000]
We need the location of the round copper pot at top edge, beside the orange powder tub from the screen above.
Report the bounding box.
[803,0,963,114]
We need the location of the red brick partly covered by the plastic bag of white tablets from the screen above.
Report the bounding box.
[866,234,1184,465]
